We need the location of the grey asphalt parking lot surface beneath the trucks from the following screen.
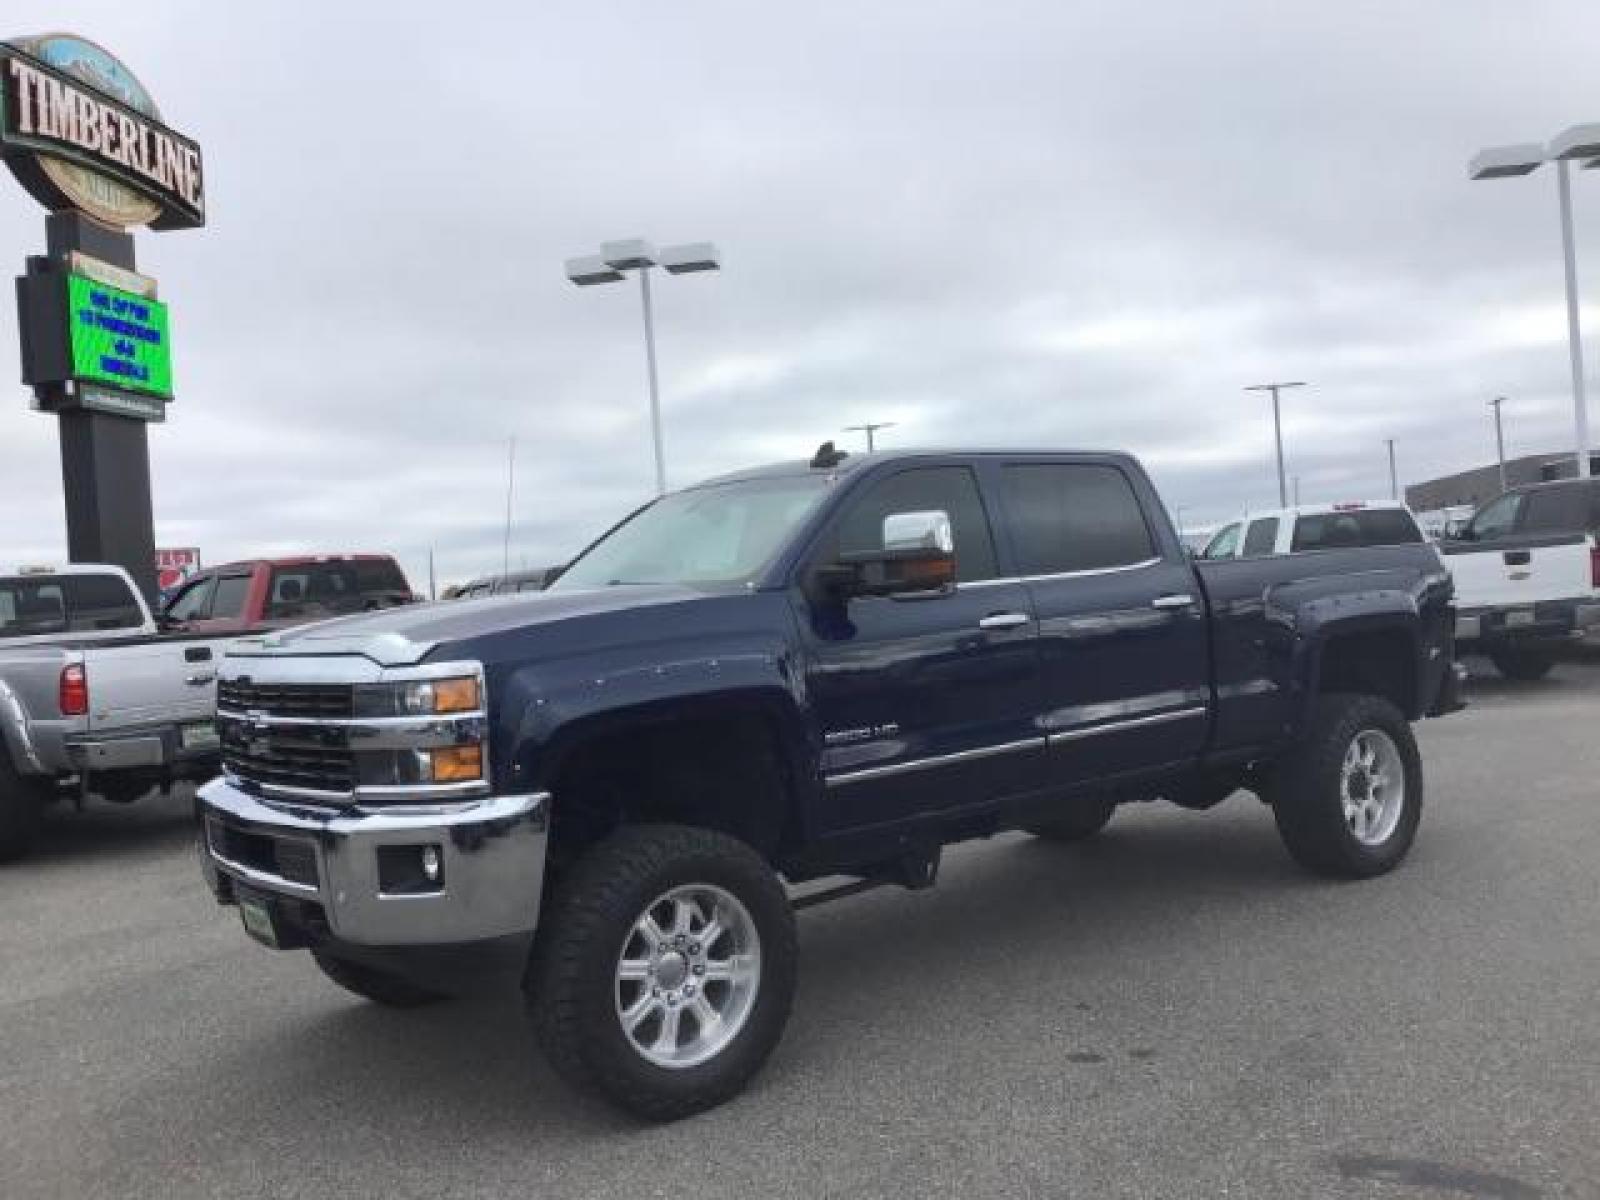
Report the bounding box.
[0,662,1600,1200]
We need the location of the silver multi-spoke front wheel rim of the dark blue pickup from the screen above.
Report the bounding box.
[616,883,762,1067]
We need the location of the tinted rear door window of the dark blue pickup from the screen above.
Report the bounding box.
[1005,462,1157,574]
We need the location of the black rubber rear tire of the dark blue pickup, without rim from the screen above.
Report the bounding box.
[1267,693,1422,878]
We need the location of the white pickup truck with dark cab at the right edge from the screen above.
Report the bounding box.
[1440,478,1600,680]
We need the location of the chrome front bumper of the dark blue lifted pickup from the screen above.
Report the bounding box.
[200,779,550,946]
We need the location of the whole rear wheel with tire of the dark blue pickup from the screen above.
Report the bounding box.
[1267,694,1422,878]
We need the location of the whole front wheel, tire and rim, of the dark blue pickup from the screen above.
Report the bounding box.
[525,826,798,1120]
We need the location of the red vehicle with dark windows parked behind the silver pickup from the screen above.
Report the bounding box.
[160,554,418,634]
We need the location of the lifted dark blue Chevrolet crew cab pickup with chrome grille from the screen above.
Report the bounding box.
[200,446,1459,1118]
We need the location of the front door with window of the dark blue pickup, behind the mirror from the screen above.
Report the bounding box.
[800,464,1045,830]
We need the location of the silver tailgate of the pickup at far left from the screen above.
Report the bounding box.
[83,637,226,733]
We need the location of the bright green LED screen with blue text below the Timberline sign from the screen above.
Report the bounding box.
[67,275,173,400]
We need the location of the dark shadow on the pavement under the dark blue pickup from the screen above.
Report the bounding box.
[181,795,1339,1141]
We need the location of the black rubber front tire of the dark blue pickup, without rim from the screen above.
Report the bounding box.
[525,824,798,1122]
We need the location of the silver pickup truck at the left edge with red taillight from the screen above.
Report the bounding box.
[0,565,227,861]
